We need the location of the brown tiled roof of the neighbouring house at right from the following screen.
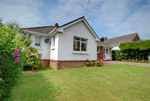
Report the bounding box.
[102,32,138,45]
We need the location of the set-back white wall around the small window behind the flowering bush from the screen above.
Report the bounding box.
[30,35,50,59]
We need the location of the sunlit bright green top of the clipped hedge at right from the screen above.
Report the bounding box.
[119,40,150,50]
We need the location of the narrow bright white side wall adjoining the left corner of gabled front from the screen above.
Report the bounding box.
[49,34,59,60]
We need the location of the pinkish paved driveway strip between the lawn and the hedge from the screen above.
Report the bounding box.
[103,61,150,66]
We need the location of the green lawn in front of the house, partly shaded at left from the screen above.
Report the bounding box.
[10,65,150,101]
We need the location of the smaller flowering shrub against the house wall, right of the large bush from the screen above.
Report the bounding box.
[26,47,41,70]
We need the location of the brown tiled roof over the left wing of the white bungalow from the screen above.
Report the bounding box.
[23,26,55,34]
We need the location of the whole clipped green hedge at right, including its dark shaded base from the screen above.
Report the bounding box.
[112,40,150,63]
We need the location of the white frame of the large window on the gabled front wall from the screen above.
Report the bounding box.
[73,36,88,52]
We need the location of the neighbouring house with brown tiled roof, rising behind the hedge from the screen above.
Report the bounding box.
[102,32,141,50]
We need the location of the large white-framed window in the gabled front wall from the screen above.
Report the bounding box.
[73,36,87,51]
